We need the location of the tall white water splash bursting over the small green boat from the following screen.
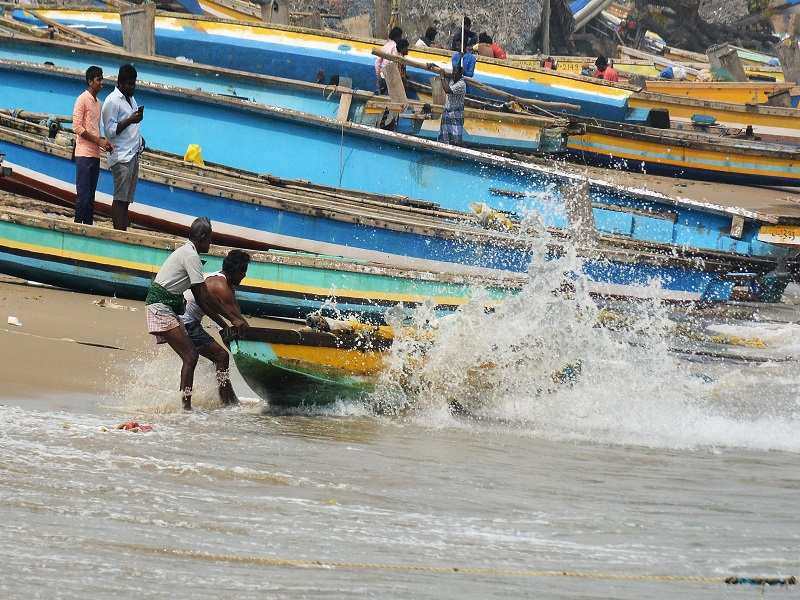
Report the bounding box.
[371,206,800,451]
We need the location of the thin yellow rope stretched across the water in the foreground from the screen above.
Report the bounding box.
[112,544,797,586]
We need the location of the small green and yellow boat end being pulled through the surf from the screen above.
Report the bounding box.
[225,323,392,406]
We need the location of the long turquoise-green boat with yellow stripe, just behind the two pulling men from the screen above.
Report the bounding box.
[0,205,525,321]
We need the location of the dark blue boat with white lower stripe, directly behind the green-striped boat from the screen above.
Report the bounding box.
[0,115,785,301]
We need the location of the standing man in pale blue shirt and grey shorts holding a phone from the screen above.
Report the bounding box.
[103,64,144,231]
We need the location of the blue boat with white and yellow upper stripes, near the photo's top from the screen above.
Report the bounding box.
[13,10,800,138]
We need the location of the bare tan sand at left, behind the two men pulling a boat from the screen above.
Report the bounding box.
[0,276,266,412]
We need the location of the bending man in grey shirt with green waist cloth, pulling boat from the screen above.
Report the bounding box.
[145,217,248,410]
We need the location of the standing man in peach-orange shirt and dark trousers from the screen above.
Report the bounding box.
[72,67,112,225]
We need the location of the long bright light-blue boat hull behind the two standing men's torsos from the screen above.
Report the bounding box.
[0,61,792,268]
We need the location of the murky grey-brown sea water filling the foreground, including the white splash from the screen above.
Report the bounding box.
[0,213,800,599]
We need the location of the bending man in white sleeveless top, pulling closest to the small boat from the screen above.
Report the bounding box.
[180,249,250,405]
